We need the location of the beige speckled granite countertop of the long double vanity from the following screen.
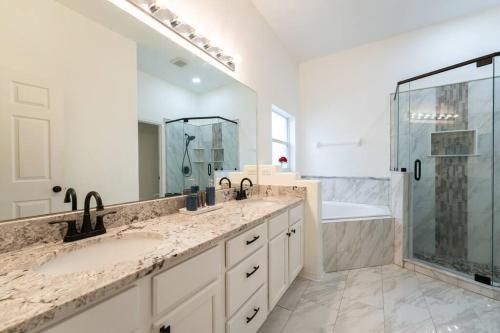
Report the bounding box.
[0,196,303,333]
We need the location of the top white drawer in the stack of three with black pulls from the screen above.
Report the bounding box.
[226,223,267,268]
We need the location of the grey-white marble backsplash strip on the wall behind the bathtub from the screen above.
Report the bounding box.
[302,176,390,206]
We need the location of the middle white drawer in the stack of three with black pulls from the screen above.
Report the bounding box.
[226,245,267,318]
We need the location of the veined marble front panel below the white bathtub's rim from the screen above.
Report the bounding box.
[322,218,394,272]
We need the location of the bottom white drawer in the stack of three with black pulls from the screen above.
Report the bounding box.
[226,285,267,333]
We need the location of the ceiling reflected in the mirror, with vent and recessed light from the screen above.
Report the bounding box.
[58,0,236,93]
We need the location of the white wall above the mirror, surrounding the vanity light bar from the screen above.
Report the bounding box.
[144,0,299,163]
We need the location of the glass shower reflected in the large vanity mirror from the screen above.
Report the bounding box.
[165,116,240,195]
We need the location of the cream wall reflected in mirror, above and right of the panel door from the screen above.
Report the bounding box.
[0,0,138,208]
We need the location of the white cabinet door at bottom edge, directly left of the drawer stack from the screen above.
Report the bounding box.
[153,281,224,333]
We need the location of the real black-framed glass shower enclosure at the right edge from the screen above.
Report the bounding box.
[391,54,500,285]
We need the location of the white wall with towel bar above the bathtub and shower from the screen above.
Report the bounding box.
[297,9,500,177]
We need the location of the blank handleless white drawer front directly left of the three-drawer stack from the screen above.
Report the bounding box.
[153,246,223,315]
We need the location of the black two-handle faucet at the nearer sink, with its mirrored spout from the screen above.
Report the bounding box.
[49,188,116,242]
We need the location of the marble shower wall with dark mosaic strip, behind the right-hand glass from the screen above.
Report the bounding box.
[398,79,500,274]
